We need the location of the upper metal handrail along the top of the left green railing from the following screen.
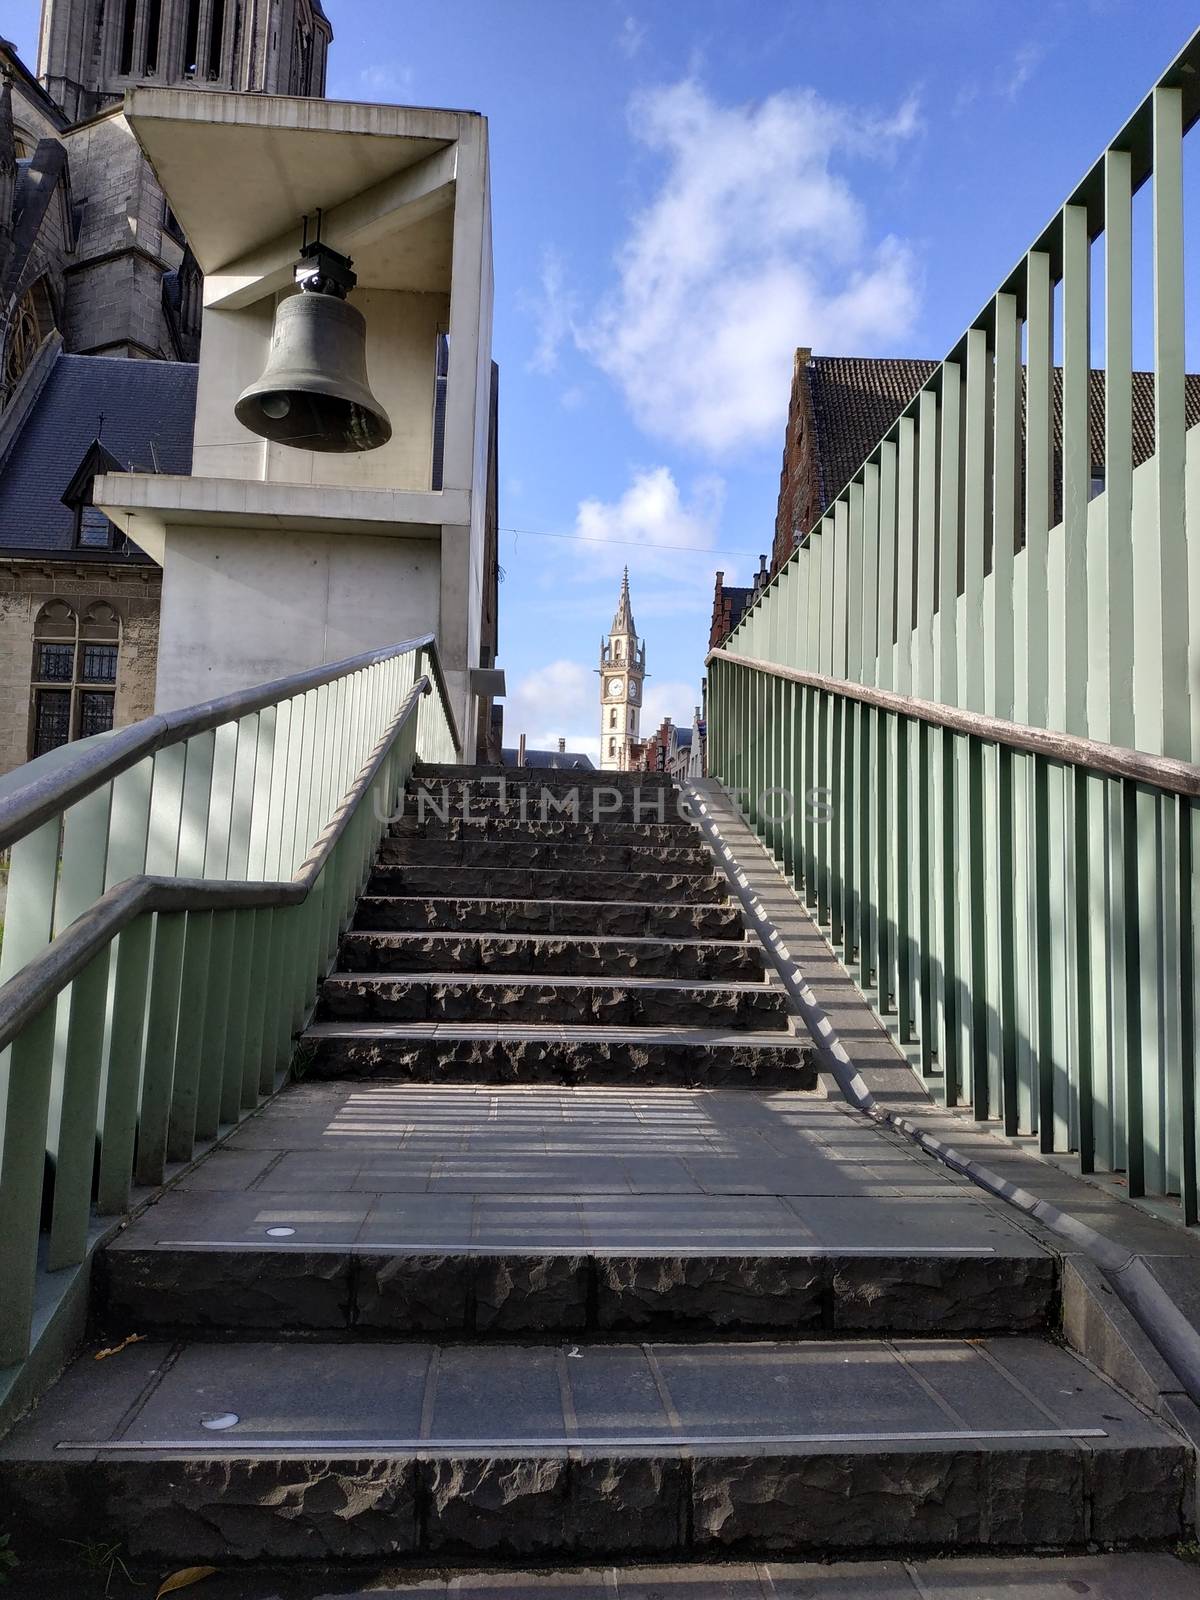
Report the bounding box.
[0,634,462,850]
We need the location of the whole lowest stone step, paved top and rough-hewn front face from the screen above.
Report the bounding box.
[0,1338,1190,1568]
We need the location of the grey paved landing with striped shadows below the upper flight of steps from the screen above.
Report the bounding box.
[117,1083,1062,1258]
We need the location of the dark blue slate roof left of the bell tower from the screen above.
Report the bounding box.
[0,355,197,560]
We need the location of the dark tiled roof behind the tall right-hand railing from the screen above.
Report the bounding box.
[809,355,1200,508]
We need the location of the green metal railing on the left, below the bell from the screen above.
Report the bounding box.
[0,635,459,1398]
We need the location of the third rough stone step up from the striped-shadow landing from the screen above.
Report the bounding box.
[338,931,766,982]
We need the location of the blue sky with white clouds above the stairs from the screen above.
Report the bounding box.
[5,0,1200,749]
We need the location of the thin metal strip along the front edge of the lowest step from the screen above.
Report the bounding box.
[54,1427,1109,1456]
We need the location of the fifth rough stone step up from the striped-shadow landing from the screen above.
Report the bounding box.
[366,862,730,906]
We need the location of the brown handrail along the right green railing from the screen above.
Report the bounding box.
[704,648,1200,800]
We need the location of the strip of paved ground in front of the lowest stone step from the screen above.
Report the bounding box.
[5,1555,1200,1600]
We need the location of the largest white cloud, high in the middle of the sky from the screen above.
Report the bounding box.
[576,78,918,453]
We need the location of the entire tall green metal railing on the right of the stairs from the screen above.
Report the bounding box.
[709,35,1200,1222]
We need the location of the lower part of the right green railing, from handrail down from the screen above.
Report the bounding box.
[709,650,1200,1222]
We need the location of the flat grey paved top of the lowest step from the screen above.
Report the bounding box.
[3,1338,1176,1461]
